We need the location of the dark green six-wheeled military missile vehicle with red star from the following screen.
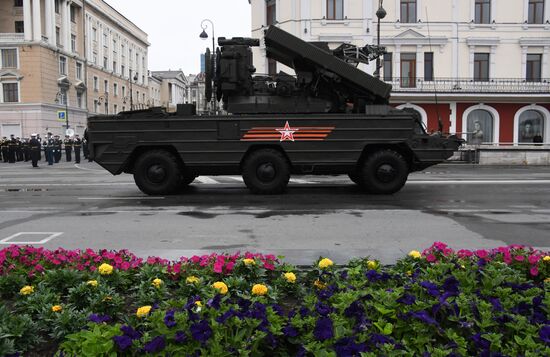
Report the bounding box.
[87,26,462,195]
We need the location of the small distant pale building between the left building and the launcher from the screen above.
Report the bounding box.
[151,70,188,111]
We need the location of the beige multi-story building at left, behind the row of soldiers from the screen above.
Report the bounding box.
[0,0,149,136]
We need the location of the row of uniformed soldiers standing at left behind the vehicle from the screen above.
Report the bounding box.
[0,132,91,167]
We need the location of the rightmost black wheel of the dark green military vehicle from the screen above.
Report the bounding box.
[361,150,409,194]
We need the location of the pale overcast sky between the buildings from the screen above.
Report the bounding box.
[105,0,251,75]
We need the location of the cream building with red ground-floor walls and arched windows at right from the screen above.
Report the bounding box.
[251,0,550,144]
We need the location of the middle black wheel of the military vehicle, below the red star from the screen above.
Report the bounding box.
[243,149,290,195]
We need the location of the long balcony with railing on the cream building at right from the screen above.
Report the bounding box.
[385,77,550,95]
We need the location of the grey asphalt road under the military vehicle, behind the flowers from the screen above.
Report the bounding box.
[0,162,550,264]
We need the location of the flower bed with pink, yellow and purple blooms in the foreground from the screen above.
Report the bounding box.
[0,242,550,356]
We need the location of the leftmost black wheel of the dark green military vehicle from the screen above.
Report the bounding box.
[134,150,183,195]
